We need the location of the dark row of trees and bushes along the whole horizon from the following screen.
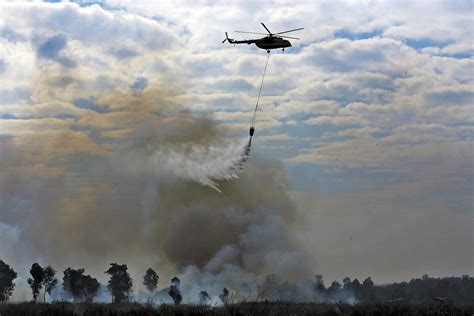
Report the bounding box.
[0,260,474,305]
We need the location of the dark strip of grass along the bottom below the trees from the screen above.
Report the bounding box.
[0,302,474,316]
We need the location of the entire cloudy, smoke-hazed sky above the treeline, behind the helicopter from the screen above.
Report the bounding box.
[0,1,474,302]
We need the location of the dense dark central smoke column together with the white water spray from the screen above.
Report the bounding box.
[114,113,314,301]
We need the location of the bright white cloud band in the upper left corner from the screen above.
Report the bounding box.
[3,3,180,49]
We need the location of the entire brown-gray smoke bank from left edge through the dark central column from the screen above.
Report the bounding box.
[0,74,314,302]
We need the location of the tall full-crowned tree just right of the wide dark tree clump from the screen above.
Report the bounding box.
[105,263,133,303]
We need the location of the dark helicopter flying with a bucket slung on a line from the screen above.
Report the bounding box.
[222,23,303,53]
